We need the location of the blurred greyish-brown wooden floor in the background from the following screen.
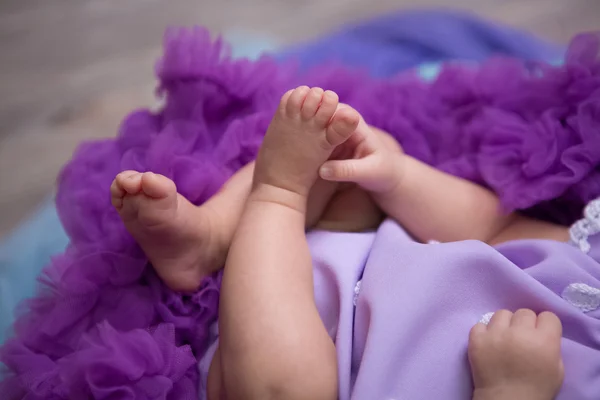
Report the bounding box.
[0,0,600,237]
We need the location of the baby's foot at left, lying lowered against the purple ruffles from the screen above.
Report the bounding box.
[110,171,226,291]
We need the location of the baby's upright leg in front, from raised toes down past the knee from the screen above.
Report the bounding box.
[209,87,359,399]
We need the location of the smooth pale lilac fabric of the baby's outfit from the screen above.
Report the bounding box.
[200,220,600,400]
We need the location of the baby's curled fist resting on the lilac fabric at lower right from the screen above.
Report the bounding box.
[468,309,564,400]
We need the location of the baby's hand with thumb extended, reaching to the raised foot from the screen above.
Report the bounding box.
[319,119,404,193]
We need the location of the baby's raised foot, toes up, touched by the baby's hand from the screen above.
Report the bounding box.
[254,86,360,196]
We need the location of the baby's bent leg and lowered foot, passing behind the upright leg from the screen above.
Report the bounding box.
[111,162,346,291]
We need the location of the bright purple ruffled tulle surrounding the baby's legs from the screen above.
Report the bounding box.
[0,29,600,399]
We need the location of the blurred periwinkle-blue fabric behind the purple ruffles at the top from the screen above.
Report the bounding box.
[279,11,563,77]
